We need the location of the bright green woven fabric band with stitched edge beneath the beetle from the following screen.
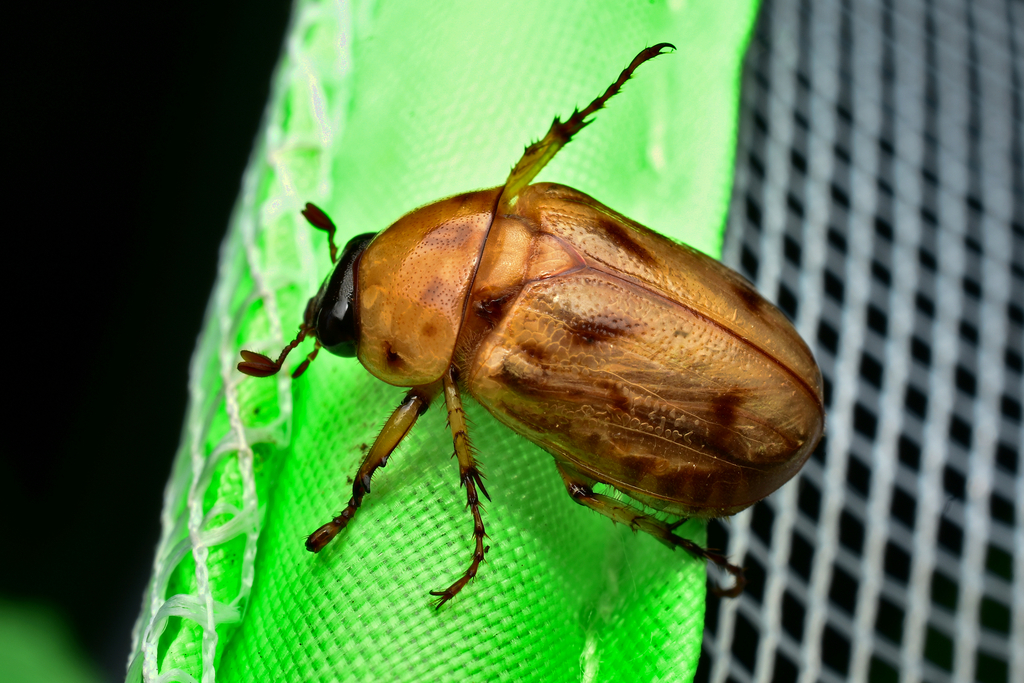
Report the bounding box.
[128,0,757,681]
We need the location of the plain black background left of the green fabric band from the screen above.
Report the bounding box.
[0,0,290,681]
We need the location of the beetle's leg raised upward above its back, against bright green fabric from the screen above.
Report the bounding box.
[498,43,676,214]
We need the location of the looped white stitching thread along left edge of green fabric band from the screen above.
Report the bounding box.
[128,3,347,683]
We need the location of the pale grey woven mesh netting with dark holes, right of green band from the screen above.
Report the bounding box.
[698,0,1024,682]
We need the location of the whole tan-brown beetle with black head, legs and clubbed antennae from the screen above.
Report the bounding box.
[239,43,824,606]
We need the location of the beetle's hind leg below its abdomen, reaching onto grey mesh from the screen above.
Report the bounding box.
[556,463,746,598]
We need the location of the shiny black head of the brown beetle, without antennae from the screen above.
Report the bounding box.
[316,232,374,357]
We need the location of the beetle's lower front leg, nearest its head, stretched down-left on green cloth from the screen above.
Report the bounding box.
[306,385,440,553]
